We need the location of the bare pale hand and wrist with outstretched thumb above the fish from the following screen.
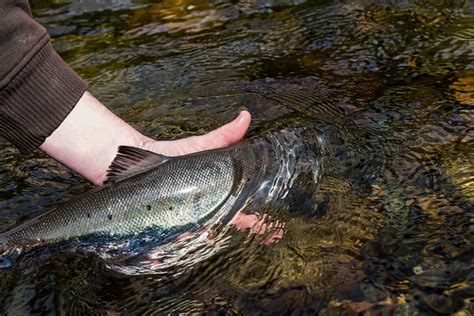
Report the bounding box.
[40,92,251,185]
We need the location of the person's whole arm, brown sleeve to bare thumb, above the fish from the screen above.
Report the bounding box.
[0,0,250,184]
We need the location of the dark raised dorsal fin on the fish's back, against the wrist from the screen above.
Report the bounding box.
[104,146,171,184]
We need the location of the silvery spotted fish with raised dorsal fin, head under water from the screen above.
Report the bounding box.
[0,130,320,264]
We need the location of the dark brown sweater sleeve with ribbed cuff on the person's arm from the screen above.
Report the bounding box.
[0,0,86,153]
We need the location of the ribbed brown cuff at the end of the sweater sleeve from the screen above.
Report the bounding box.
[0,42,87,153]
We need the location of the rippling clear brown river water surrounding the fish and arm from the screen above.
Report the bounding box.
[0,1,474,314]
